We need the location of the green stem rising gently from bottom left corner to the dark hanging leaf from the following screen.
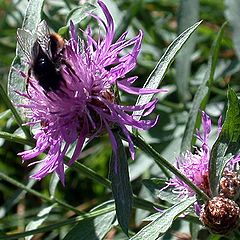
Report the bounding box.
[1,206,115,240]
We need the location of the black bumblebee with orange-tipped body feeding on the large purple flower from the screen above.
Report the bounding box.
[17,20,64,92]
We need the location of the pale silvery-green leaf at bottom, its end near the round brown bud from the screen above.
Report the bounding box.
[131,197,196,240]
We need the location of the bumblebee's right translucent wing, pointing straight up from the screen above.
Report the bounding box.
[36,20,52,59]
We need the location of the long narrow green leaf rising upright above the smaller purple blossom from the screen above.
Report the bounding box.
[181,23,226,152]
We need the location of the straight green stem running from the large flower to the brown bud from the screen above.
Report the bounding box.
[131,135,209,200]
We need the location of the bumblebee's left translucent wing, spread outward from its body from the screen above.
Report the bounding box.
[17,28,34,62]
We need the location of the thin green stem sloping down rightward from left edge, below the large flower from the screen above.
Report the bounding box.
[0,172,83,215]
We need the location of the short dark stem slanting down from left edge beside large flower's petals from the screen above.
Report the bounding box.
[0,84,31,138]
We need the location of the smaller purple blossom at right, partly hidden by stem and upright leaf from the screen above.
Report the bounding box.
[164,112,240,197]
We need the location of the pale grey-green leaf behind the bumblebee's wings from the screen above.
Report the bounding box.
[8,0,44,115]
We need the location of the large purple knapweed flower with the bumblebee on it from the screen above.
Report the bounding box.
[19,1,163,184]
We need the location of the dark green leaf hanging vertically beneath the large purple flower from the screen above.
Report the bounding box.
[109,131,133,235]
